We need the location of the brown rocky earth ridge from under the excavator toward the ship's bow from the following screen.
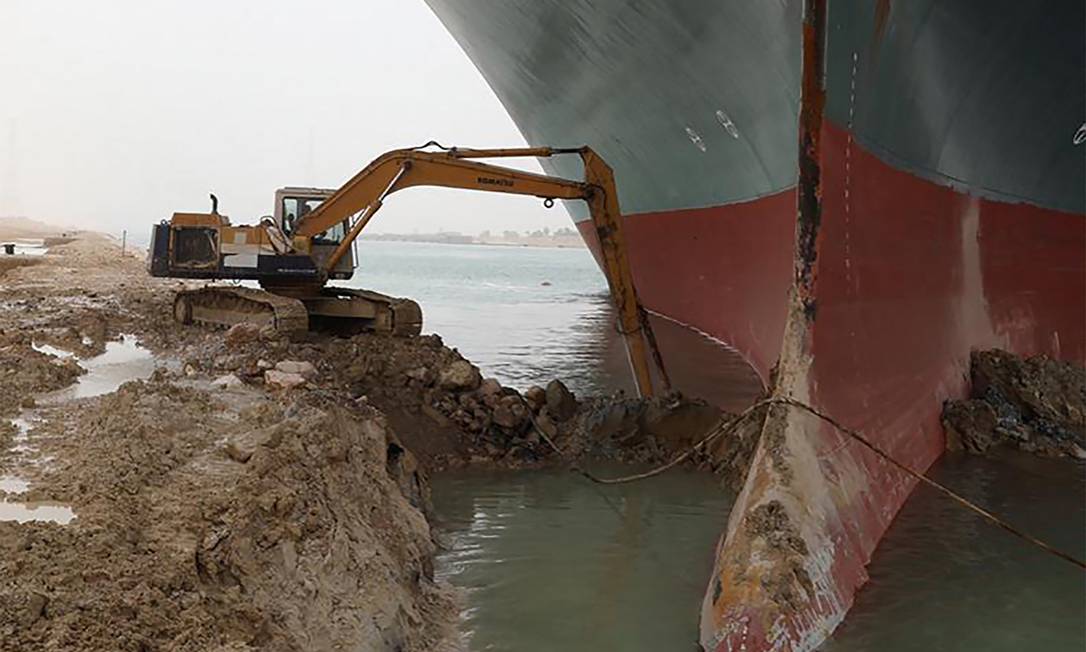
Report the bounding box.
[184,334,756,477]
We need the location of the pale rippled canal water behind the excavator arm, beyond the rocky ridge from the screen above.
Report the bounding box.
[350,241,761,409]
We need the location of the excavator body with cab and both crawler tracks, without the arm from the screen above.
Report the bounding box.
[148,187,422,335]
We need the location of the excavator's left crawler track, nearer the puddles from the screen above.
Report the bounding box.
[174,286,310,333]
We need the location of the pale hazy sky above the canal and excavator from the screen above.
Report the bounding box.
[0,0,569,239]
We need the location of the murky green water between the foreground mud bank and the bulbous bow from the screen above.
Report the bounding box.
[433,467,731,652]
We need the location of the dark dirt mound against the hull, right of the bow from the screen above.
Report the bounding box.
[943,350,1086,459]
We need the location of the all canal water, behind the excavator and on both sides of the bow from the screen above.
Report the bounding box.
[353,241,1086,652]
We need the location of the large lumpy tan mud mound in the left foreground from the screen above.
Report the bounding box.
[0,379,453,650]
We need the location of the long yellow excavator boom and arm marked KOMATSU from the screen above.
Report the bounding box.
[293,147,669,397]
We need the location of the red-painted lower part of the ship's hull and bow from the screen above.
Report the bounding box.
[580,119,1086,651]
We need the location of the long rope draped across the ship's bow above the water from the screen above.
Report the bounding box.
[528,397,1086,572]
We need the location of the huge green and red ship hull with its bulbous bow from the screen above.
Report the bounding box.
[428,0,1086,650]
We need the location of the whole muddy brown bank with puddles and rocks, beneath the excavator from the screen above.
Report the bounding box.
[0,229,754,651]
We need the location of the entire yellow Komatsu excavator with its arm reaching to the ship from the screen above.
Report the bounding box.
[151,143,668,396]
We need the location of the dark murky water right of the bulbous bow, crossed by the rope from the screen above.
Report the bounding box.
[824,453,1086,652]
